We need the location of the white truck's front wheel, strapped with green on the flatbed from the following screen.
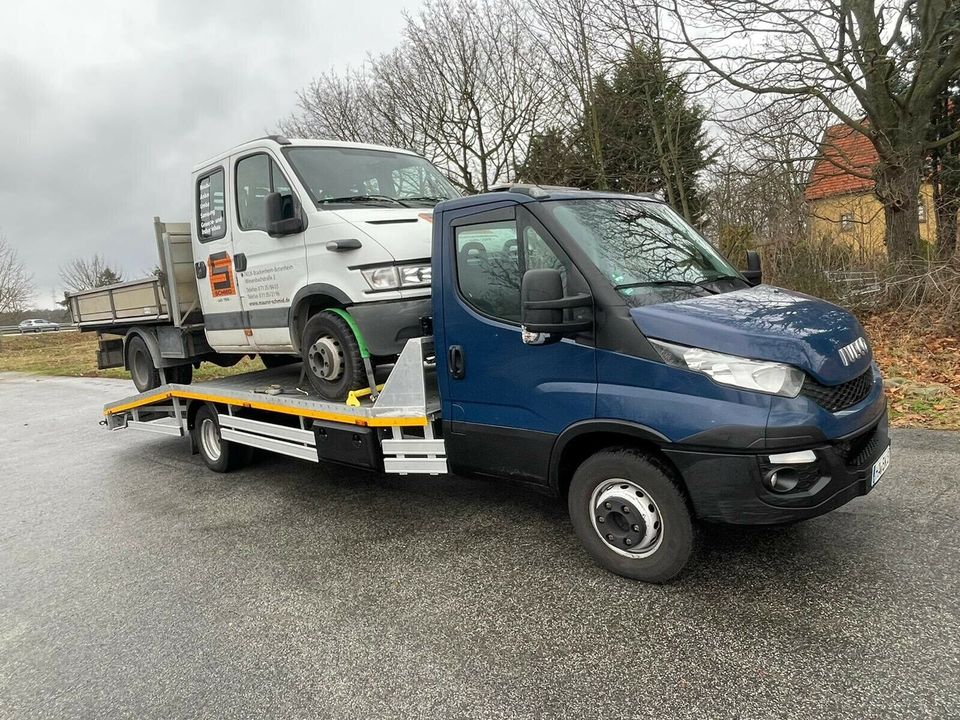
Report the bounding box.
[300,312,367,402]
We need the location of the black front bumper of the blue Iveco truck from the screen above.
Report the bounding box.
[663,411,890,525]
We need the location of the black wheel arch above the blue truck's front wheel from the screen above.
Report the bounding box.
[549,420,683,498]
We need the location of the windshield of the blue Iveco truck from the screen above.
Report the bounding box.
[543,198,747,305]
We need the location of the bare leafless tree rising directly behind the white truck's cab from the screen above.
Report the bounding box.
[282,0,555,192]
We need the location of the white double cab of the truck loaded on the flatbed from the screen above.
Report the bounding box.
[191,136,459,399]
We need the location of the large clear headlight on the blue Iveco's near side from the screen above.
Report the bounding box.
[650,340,804,397]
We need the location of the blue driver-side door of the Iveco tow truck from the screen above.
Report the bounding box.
[434,206,597,483]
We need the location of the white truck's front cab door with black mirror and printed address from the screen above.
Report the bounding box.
[233,150,307,352]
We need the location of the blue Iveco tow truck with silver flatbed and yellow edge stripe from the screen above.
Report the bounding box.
[105,185,890,582]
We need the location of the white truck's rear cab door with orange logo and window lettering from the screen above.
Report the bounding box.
[192,162,249,352]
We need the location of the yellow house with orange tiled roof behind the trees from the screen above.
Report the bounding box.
[804,124,937,260]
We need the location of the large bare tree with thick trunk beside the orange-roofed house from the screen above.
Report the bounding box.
[662,0,960,259]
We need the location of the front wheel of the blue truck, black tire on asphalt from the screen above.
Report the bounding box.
[567,448,694,583]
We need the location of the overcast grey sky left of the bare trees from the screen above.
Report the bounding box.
[0,0,419,307]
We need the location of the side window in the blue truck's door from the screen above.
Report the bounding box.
[456,220,563,323]
